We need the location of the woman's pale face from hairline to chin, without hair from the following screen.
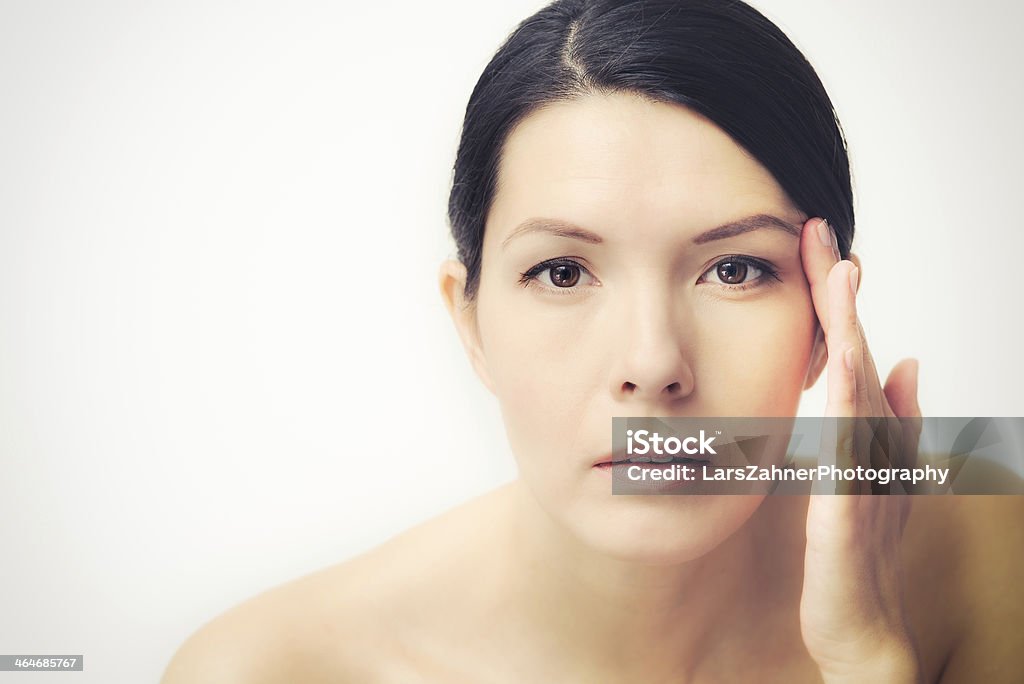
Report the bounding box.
[449,94,823,563]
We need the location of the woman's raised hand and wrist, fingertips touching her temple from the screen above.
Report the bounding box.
[800,218,924,684]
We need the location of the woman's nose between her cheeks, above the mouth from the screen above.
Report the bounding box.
[611,290,693,402]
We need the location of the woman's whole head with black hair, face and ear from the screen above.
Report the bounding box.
[442,1,853,562]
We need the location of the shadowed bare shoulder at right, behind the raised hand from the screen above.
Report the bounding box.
[904,466,1024,684]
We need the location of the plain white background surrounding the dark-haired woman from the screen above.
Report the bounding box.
[0,0,1024,683]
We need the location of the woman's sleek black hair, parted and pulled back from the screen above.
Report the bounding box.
[449,0,854,302]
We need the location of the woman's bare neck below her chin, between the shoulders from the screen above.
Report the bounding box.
[502,481,802,681]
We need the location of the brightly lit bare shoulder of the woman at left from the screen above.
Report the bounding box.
[161,487,505,684]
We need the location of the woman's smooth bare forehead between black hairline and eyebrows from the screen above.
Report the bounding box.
[488,93,796,244]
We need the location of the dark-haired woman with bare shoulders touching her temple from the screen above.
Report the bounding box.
[164,0,1024,684]
